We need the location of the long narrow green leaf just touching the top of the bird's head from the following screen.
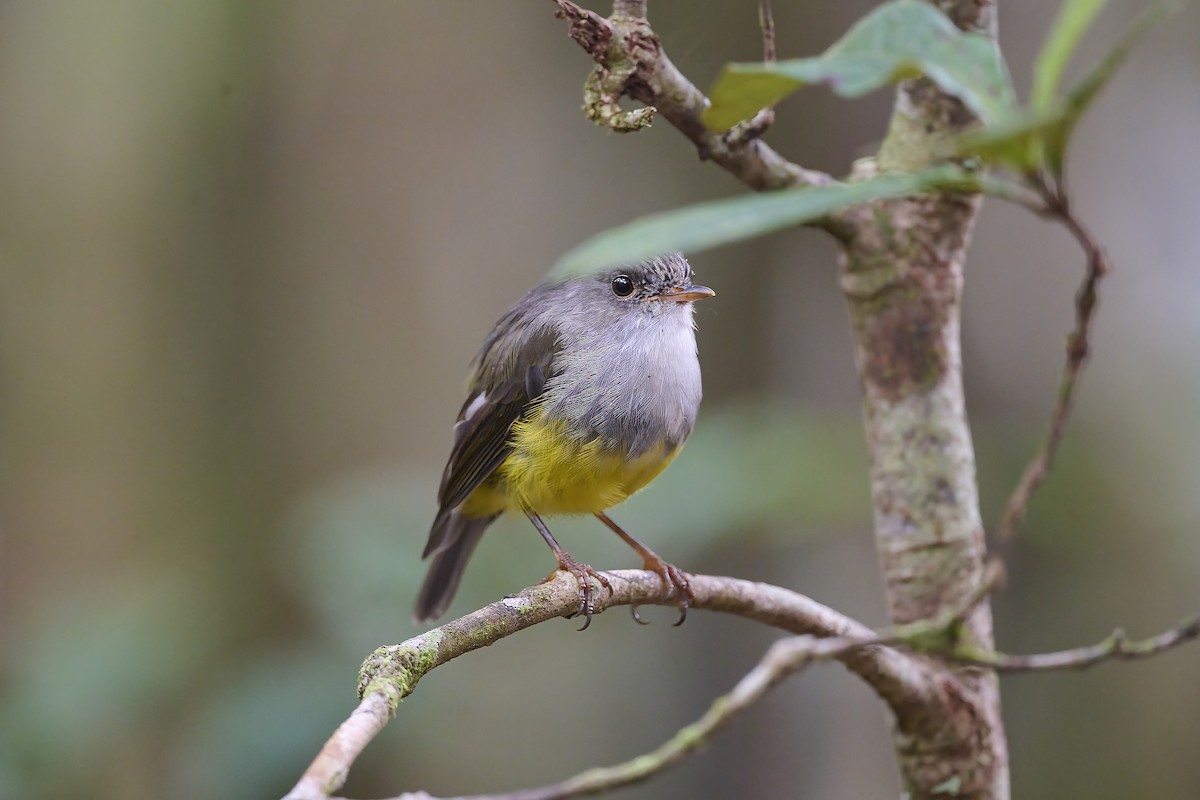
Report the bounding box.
[551,164,977,277]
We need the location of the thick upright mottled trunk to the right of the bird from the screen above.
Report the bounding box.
[841,0,1008,800]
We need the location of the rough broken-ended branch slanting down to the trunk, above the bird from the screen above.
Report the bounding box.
[554,0,834,191]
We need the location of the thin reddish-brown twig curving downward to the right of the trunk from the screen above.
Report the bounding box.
[997,178,1110,546]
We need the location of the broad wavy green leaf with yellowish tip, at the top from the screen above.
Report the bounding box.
[704,0,1016,131]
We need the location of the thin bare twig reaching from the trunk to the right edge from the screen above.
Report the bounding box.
[948,616,1200,672]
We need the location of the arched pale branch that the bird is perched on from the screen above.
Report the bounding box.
[287,570,953,800]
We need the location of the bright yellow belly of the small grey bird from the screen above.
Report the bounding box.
[462,416,679,517]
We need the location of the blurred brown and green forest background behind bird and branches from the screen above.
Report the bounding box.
[0,0,1200,800]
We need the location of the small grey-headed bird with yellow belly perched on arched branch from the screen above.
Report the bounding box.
[416,253,715,630]
